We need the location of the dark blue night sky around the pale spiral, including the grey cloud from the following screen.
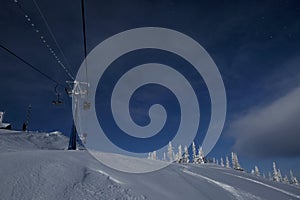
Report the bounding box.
[0,0,300,176]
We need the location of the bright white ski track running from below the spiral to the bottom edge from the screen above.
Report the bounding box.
[182,169,261,200]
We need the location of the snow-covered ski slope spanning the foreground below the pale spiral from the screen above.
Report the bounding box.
[0,130,300,200]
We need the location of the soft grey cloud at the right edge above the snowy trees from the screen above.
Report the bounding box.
[229,86,300,157]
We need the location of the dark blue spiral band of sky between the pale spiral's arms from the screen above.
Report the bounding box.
[96,49,211,152]
